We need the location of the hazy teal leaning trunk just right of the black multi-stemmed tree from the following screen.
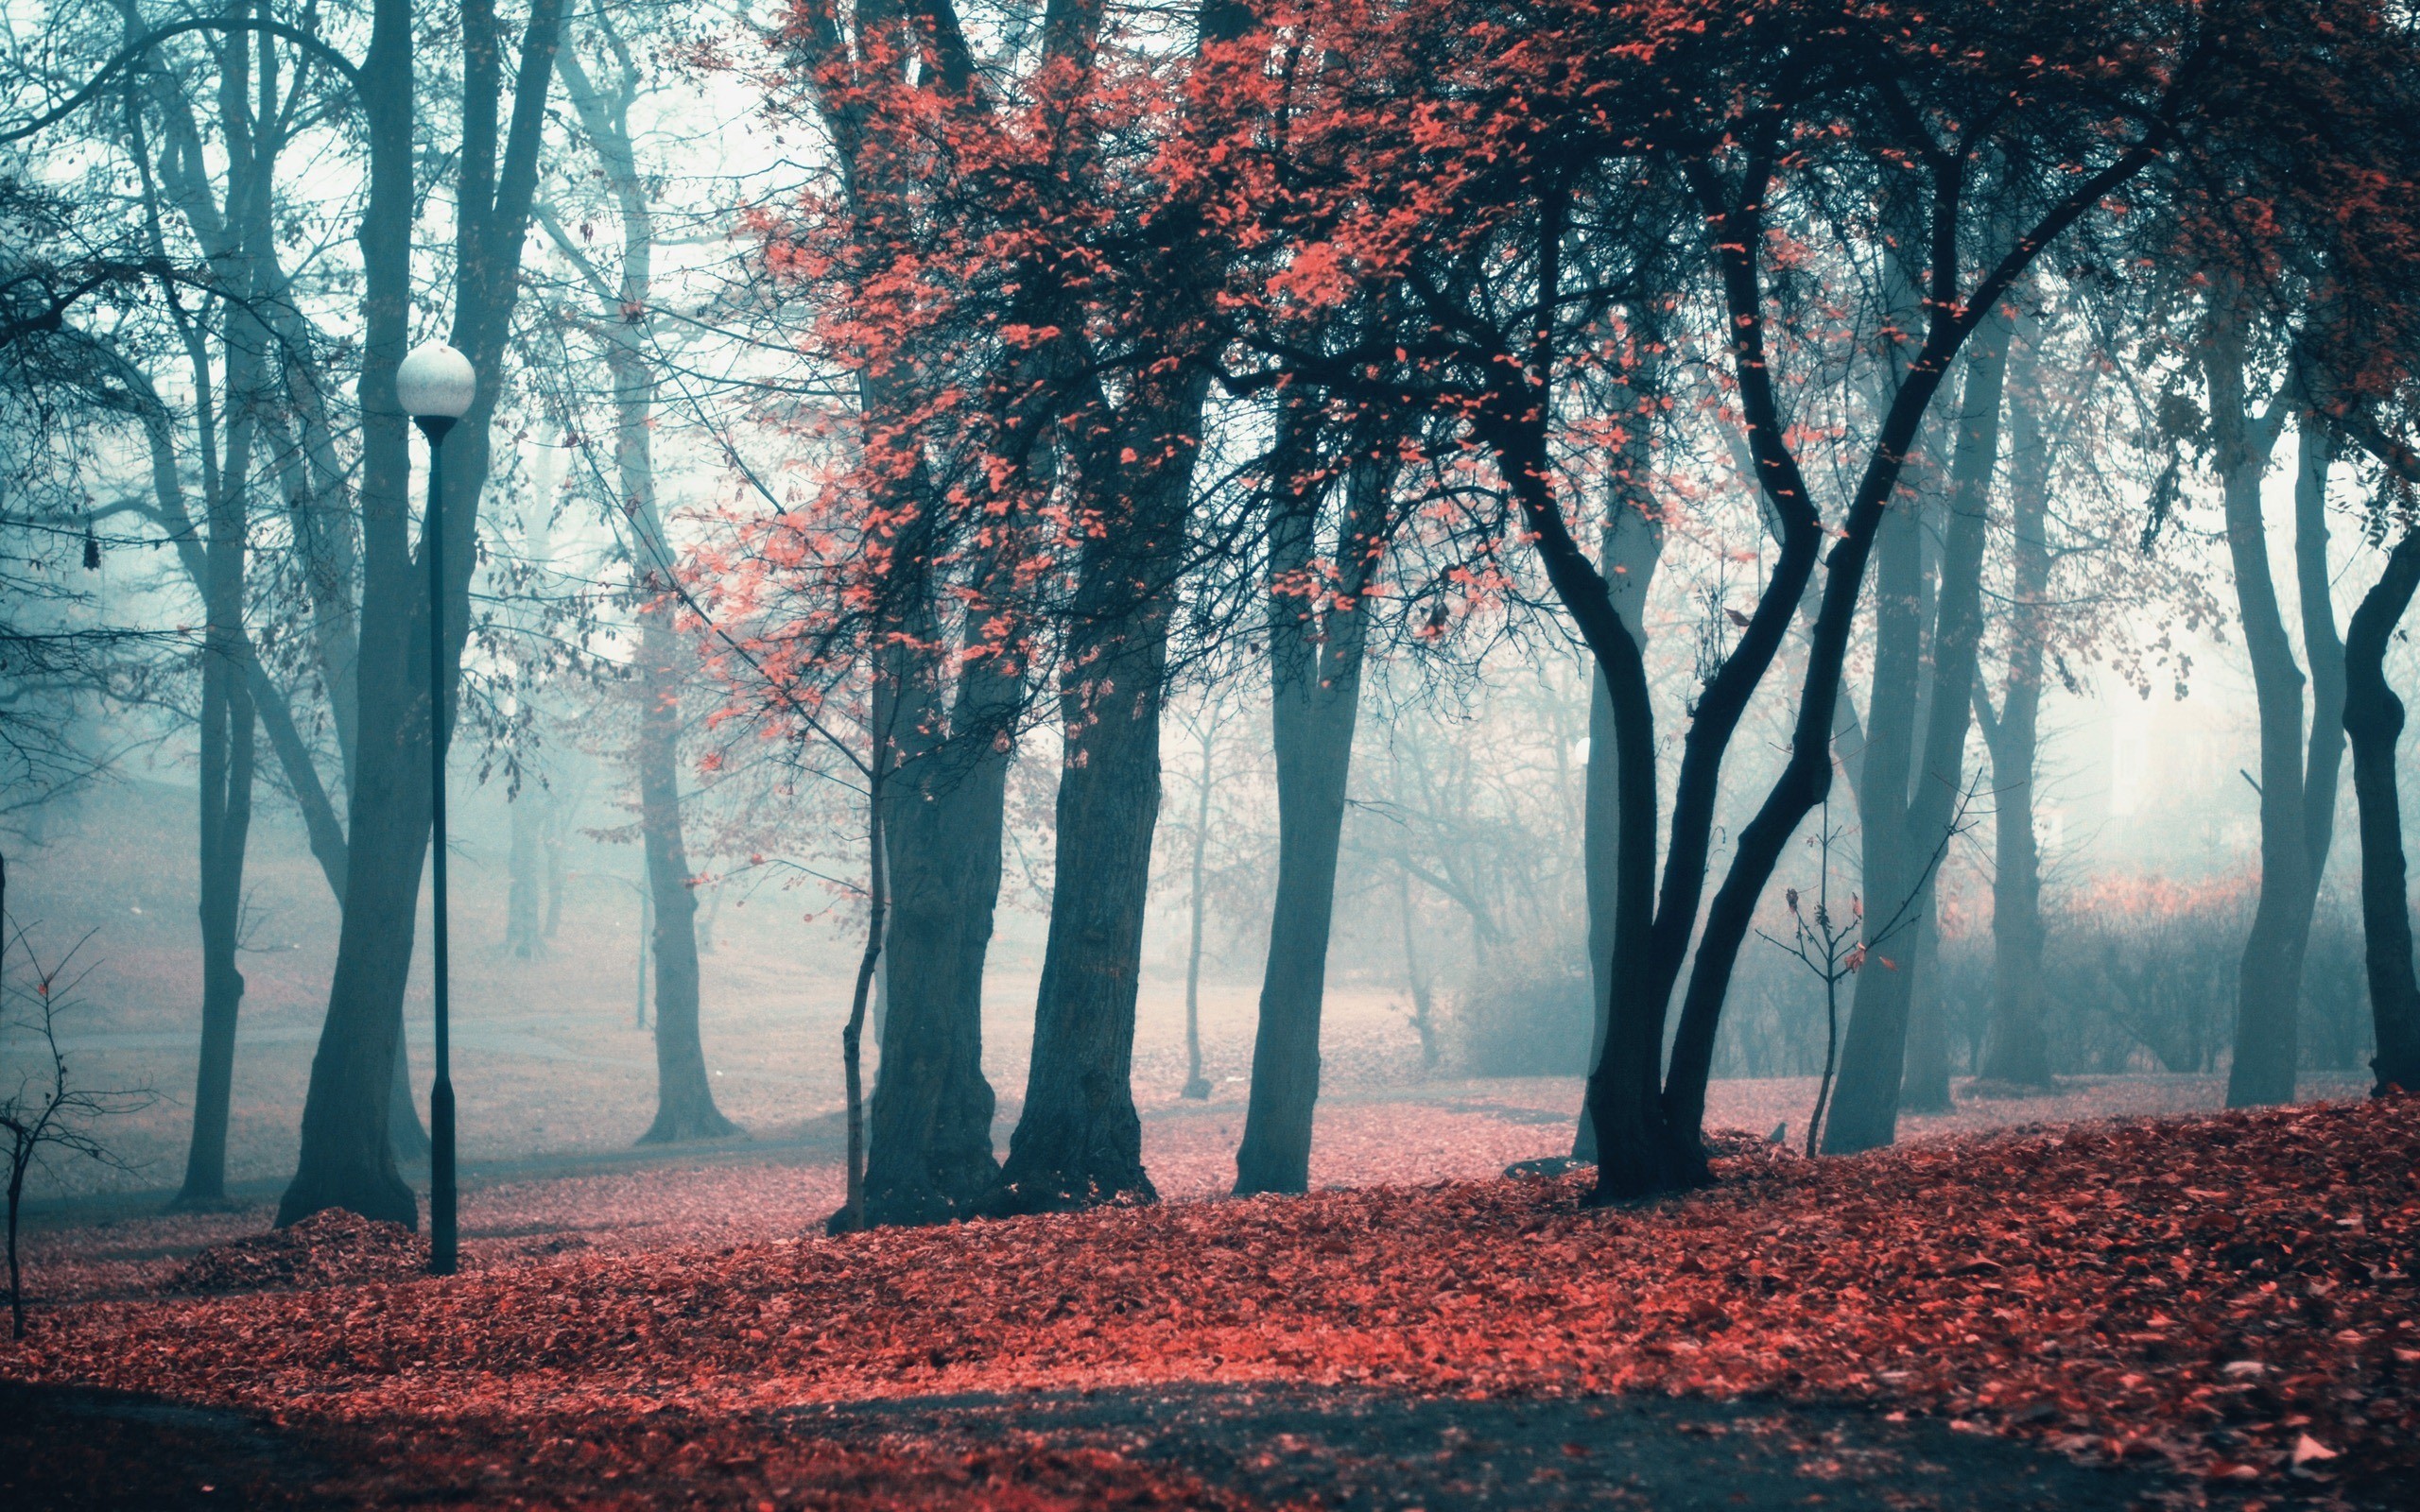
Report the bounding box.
[1823,310,2011,1154]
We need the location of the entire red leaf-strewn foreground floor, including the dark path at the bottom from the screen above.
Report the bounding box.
[0,1098,2420,1509]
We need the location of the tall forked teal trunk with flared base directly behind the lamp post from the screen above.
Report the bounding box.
[278,0,562,1224]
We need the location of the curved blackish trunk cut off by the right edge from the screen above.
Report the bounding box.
[2345,530,2420,1096]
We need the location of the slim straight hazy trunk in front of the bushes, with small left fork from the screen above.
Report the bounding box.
[1975,329,2052,1086]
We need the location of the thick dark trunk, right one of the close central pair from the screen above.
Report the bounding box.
[990,387,1205,1212]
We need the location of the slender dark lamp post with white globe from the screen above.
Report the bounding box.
[394,341,479,1275]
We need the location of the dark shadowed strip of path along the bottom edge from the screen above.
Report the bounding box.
[0,1386,2178,1512]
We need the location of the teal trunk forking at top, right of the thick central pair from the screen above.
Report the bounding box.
[1235,447,1394,1197]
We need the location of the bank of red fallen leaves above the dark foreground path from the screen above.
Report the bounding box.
[0,1098,2420,1504]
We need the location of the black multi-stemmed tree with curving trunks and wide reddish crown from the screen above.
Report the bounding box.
[1188,5,2212,1200]
